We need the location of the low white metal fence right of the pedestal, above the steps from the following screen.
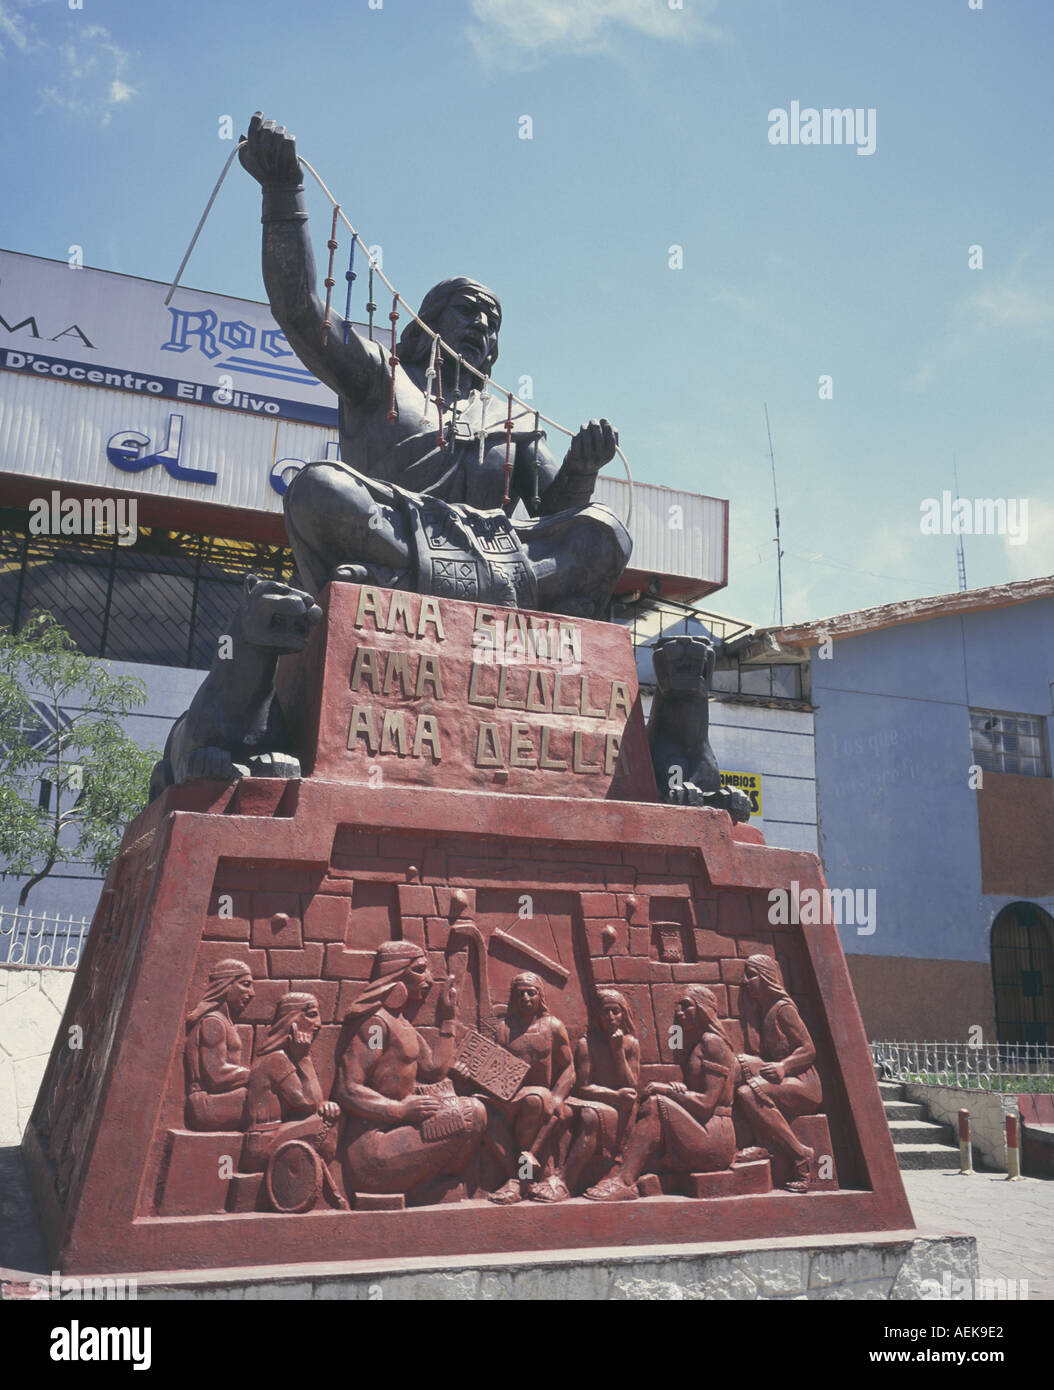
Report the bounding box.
[870,1041,1054,1091]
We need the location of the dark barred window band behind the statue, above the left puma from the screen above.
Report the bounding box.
[0,512,292,670]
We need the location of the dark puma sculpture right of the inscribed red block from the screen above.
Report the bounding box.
[648,637,751,821]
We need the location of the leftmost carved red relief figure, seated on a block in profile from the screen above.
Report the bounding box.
[184,959,256,1130]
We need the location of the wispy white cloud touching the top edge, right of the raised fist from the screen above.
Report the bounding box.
[469,0,719,63]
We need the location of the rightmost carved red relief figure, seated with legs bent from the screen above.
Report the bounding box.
[736,955,823,1193]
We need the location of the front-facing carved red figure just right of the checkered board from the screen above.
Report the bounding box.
[487,970,574,1205]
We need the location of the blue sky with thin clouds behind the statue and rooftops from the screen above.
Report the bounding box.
[0,0,1054,623]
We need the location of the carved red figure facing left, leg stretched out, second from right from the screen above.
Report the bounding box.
[585,984,736,1202]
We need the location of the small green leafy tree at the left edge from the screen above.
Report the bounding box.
[0,613,160,908]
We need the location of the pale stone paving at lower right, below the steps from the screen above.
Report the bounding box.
[901,1169,1054,1300]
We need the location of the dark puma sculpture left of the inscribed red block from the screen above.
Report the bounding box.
[150,574,323,799]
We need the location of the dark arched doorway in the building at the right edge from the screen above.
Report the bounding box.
[991,902,1054,1044]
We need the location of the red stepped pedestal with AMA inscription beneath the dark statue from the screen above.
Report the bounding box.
[24,585,912,1273]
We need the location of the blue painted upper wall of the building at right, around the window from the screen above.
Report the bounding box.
[812,599,1054,962]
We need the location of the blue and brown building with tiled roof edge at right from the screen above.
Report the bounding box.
[770,577,1054,1044]
